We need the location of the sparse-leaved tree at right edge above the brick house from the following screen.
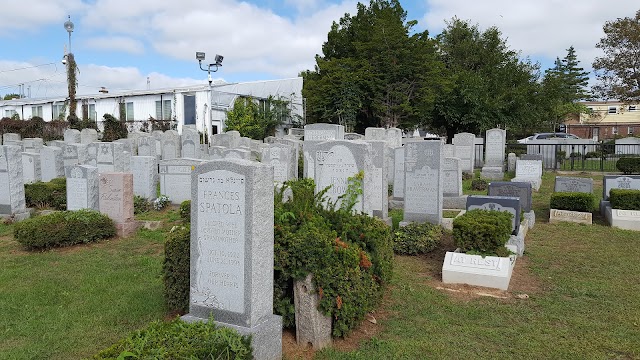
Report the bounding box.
[593,10,640,103]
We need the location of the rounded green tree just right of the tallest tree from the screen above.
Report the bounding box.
[432,18,540,138]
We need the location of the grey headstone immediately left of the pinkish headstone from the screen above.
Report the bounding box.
[64,165,100,211]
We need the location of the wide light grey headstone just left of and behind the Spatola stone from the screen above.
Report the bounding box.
[159,159,203,205]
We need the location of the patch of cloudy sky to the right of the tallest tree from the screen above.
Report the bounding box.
[423,0,638,69]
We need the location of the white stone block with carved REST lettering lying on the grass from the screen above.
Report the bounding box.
[442,245,517,290]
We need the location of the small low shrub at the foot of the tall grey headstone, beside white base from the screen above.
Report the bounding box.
[393,223,443,255]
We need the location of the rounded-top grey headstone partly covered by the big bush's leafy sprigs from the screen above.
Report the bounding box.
[314,140,373,215]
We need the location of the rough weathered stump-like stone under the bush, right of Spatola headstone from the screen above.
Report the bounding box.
[293,274,331,350]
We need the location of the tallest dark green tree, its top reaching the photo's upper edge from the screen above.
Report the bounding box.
[301,0,442,131]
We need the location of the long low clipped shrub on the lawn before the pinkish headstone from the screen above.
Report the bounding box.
[13,210,116,250]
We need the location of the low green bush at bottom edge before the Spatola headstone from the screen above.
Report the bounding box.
[93,319,253,360]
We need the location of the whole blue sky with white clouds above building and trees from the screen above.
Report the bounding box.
[0,0,640,98]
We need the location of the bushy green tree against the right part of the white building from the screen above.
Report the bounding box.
[225,96,291,140]
